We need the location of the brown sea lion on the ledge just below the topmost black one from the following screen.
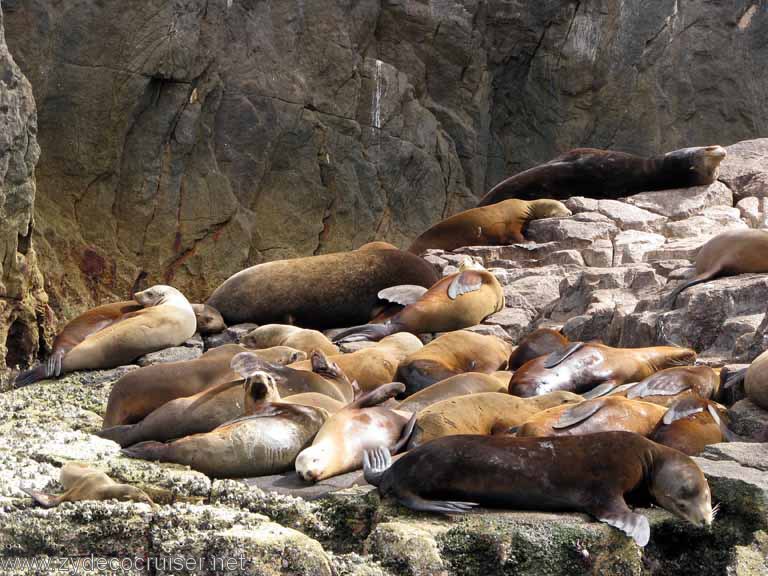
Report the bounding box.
[408,199,571,254]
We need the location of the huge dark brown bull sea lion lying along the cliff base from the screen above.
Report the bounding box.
[207,250,438,329]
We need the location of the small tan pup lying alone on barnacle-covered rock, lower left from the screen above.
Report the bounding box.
[21,462,156,508]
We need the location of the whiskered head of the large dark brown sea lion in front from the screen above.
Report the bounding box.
[649,449,716,526]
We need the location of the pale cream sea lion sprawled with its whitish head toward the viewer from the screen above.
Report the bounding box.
[296,382,416,482]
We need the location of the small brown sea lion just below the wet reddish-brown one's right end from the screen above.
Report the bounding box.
[584,366,720,406]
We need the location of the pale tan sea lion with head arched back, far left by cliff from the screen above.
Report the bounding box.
[16,284,197,387]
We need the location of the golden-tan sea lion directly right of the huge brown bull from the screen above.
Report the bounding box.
[333,258,504,342]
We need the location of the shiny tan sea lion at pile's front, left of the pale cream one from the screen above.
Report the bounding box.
[122,402,328,478]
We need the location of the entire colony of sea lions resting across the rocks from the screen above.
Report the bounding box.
[16,146,768,546]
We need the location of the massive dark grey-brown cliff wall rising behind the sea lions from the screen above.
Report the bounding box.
[4,0,768,318]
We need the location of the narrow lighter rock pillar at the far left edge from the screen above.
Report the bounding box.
[0,4,53,381]
